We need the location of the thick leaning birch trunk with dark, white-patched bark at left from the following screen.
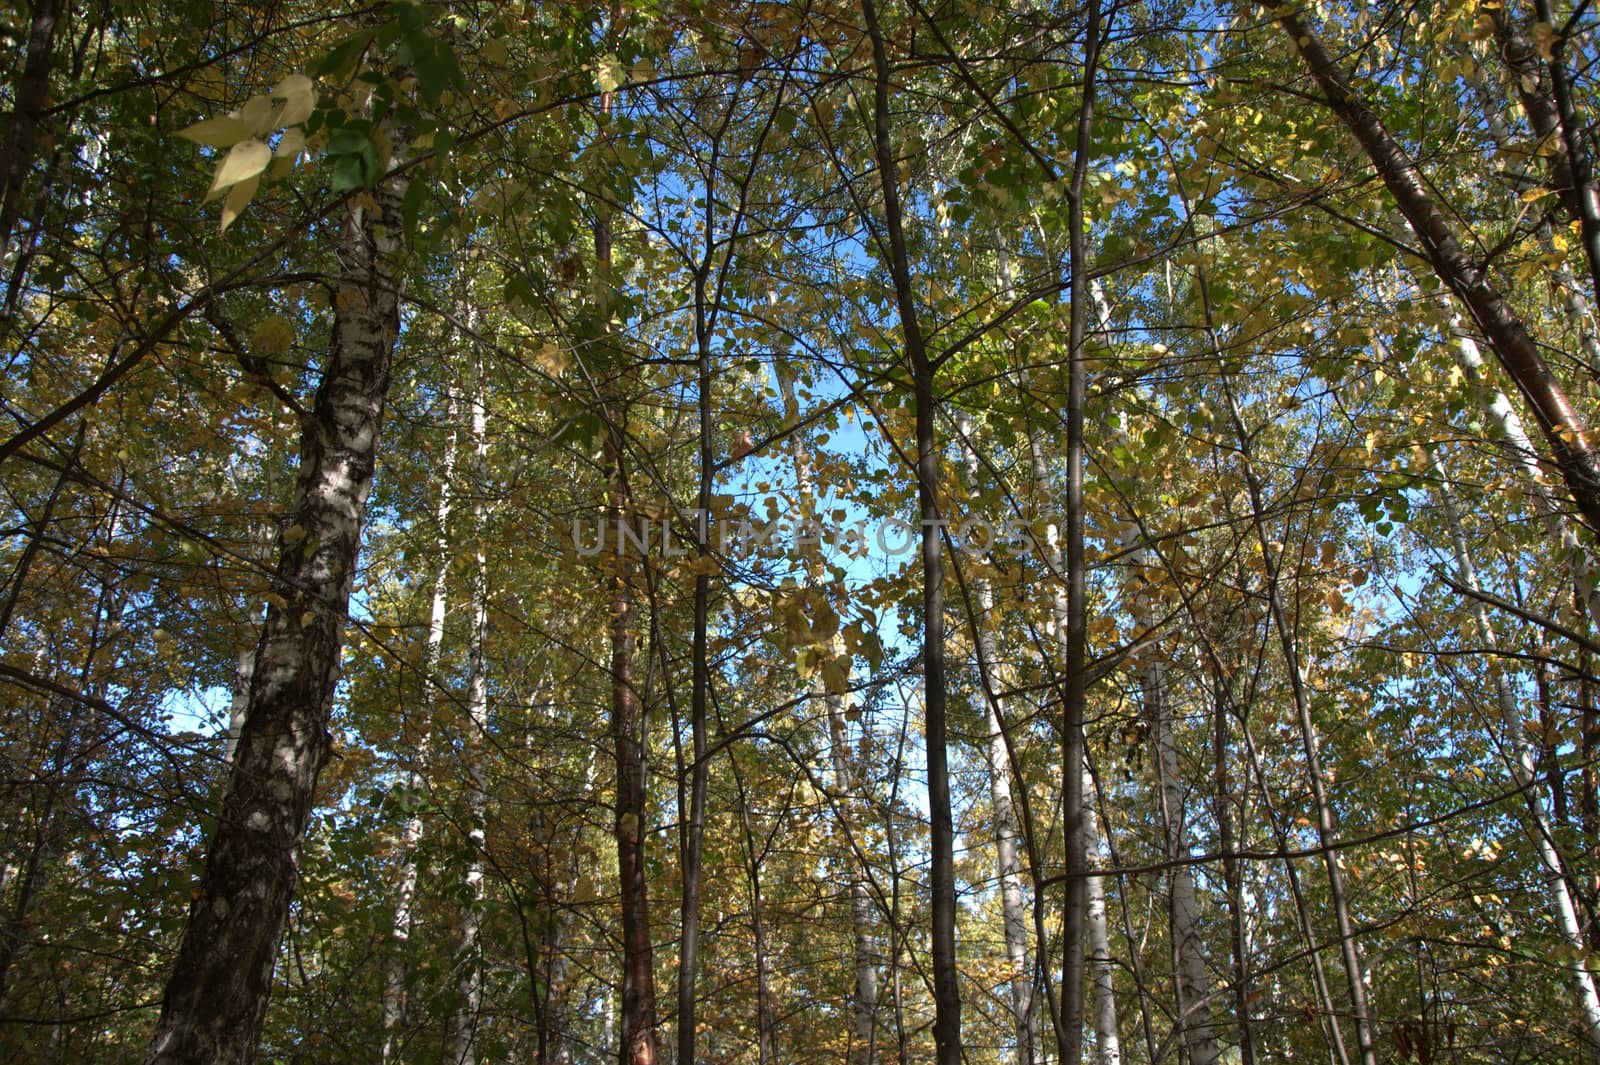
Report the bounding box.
[147,153,405,1065]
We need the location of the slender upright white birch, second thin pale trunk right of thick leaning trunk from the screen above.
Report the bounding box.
[445,357,490,1065]
